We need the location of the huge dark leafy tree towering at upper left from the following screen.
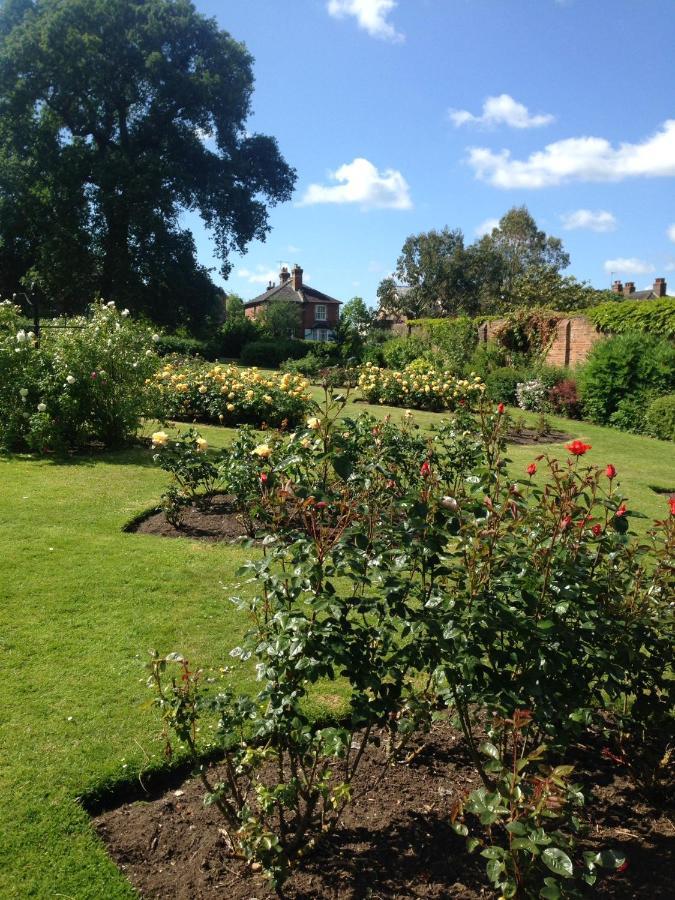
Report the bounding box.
[0,0,295,323]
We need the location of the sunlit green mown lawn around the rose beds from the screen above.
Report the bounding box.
[0,402,675,900]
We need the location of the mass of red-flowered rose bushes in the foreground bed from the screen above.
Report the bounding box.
[150,398,675,897]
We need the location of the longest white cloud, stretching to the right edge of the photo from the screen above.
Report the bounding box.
[469,119,675,188]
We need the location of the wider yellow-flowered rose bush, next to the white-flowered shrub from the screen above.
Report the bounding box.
[153,361,310,425]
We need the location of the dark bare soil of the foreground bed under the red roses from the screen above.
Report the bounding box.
[94,724,675,900]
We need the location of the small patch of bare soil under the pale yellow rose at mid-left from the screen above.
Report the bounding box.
[125,494,251,541]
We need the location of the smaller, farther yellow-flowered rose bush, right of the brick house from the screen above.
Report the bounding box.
[359,360,484,410]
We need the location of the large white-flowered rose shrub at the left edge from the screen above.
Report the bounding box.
[0,301,159,451]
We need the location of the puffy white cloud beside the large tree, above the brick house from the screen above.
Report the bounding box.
[299,158,412,209]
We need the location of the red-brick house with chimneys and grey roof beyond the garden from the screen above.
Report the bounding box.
[244,264,341,341]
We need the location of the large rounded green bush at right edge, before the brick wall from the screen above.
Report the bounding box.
[579,334,675,425]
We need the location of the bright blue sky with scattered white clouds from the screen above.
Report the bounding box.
[189,0,675,305]
